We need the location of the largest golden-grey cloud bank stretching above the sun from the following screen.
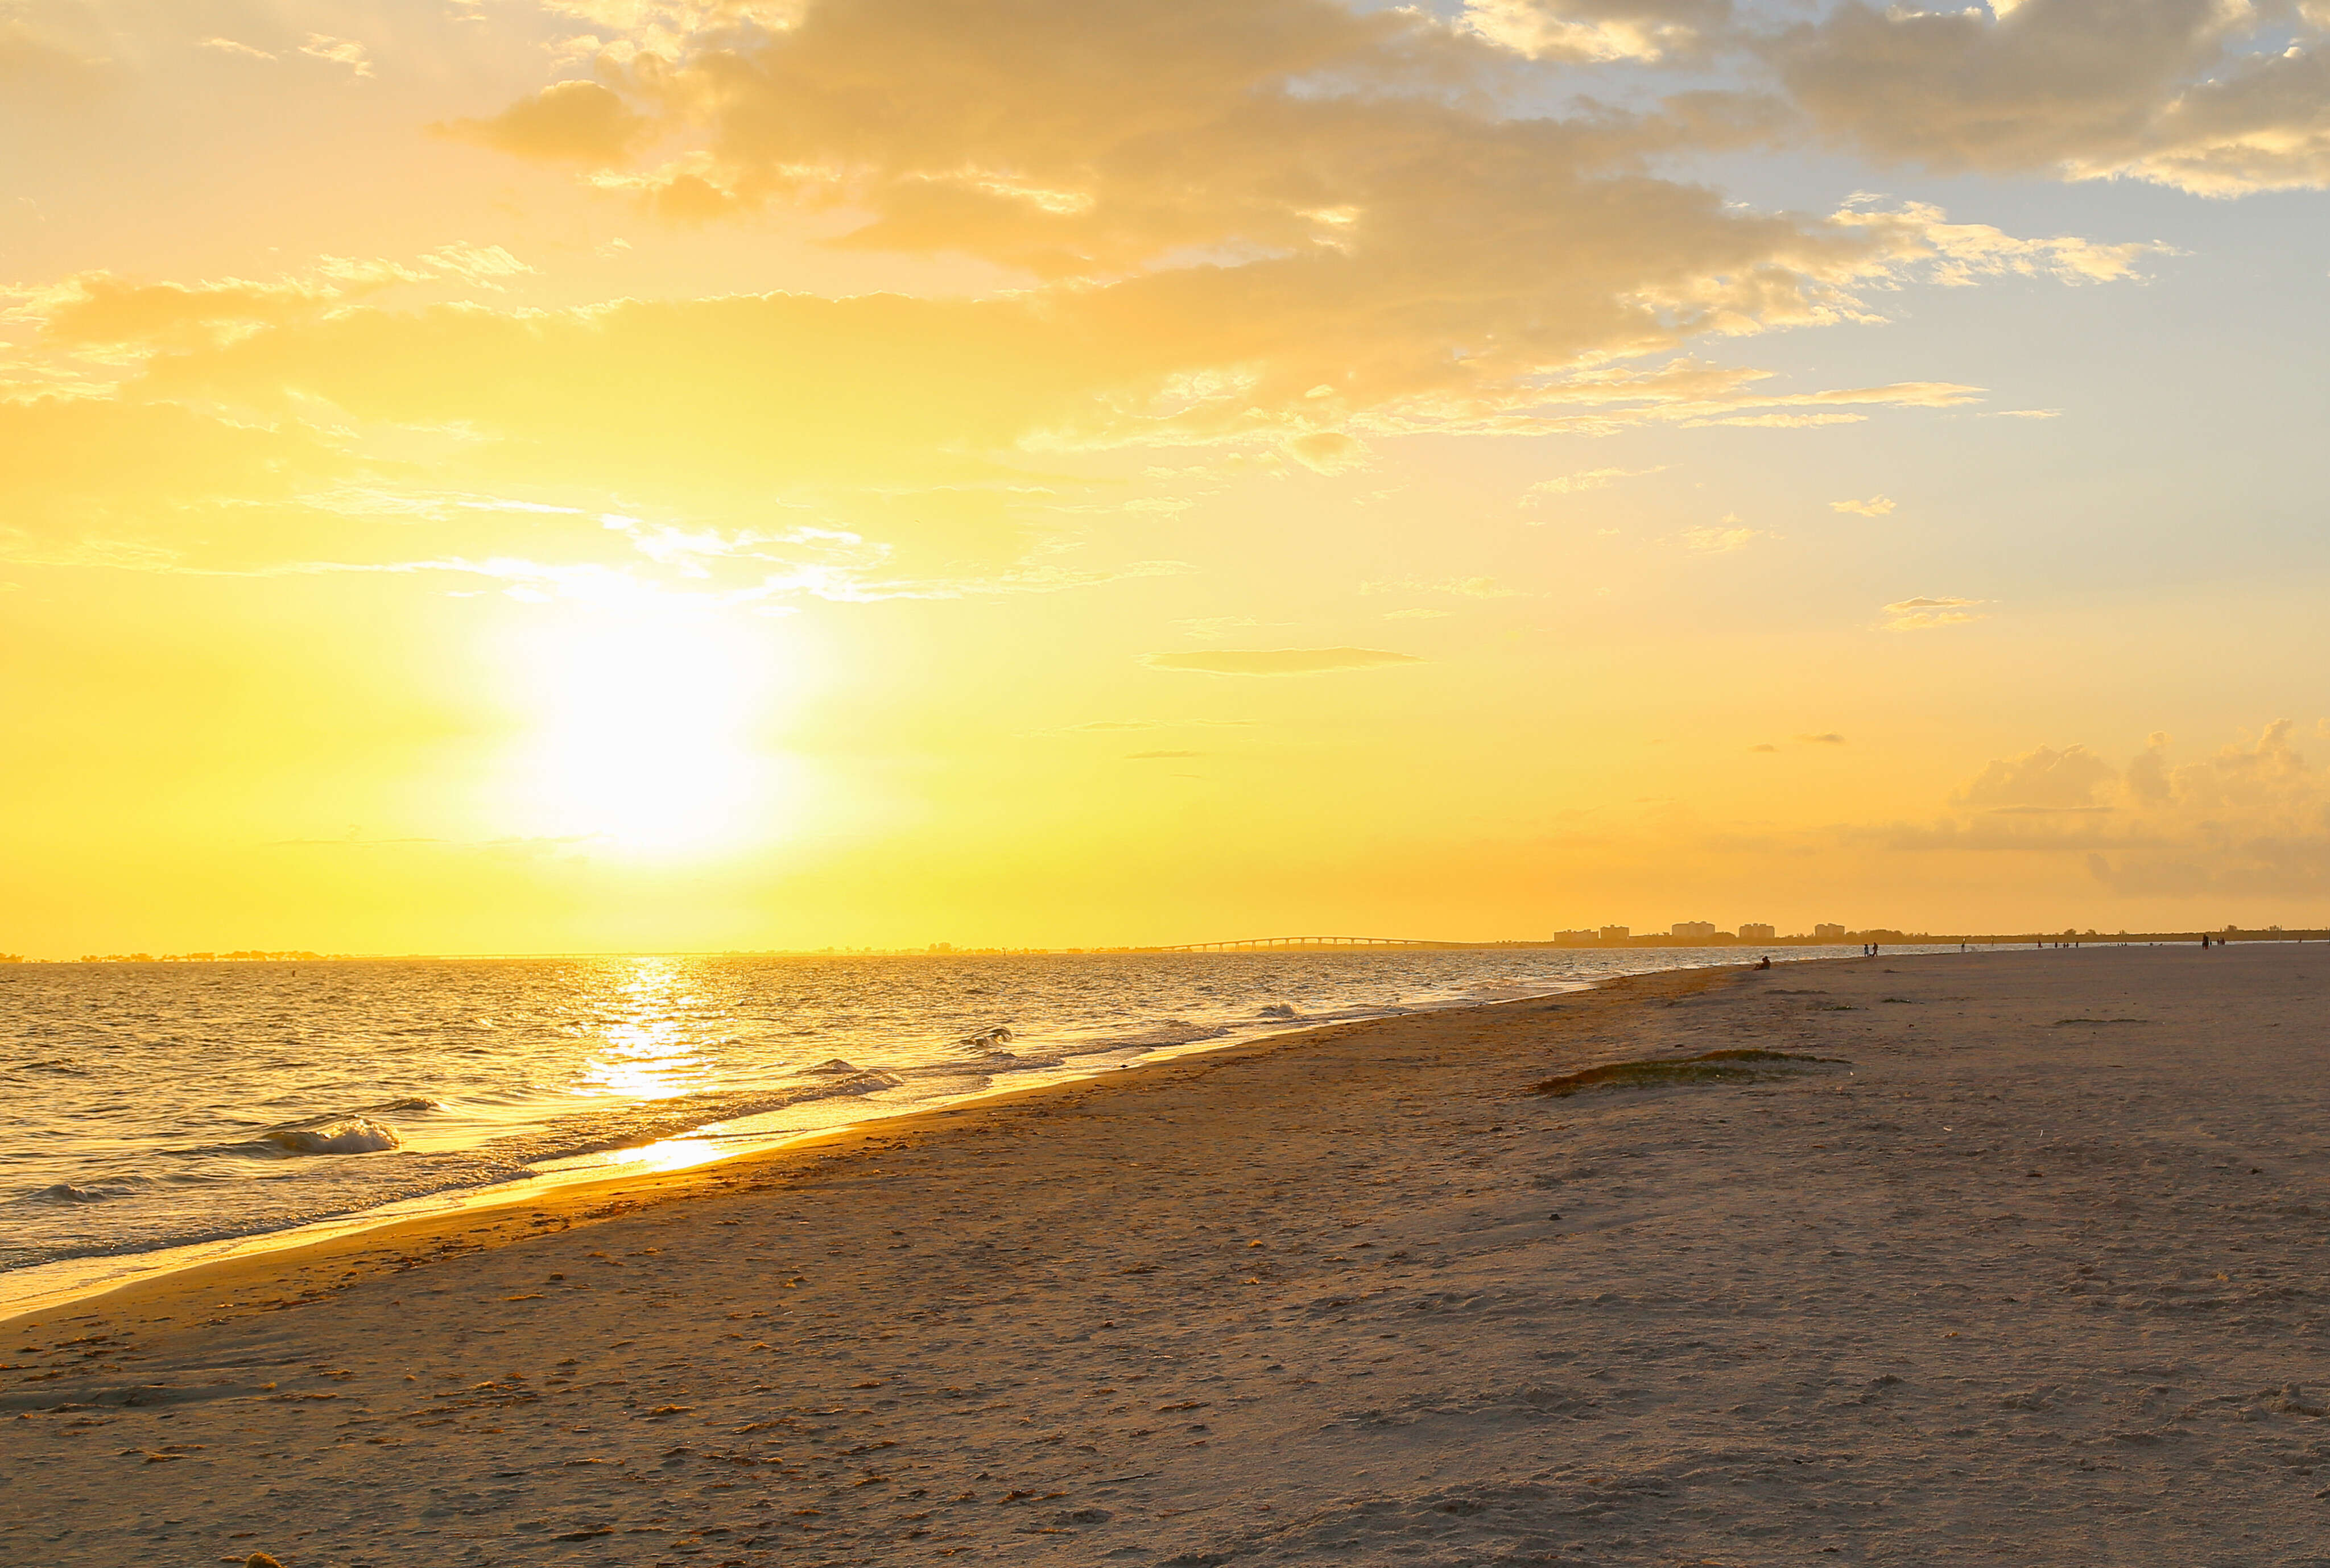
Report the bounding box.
[9,0,2171,601]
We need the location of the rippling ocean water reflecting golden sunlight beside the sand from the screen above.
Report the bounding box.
[0,946,1955,1307]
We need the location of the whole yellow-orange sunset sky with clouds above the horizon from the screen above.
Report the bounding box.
[0,0,2330,958]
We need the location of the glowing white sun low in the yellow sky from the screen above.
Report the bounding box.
[513,599,783,853]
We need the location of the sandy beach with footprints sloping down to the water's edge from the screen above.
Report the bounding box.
[0,944,2330,1568]
